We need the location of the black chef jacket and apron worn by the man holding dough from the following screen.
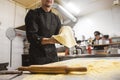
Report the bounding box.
[25,8,61,65]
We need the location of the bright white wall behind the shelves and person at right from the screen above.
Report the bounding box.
[74,5,120,40]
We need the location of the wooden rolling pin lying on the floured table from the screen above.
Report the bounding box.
[18,65,87,74]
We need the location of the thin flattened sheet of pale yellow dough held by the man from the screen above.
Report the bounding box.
[52,26,77,48]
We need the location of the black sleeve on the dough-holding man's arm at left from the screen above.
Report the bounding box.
[25,10,43,45]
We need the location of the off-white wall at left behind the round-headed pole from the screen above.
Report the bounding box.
[0,0,26,69]
